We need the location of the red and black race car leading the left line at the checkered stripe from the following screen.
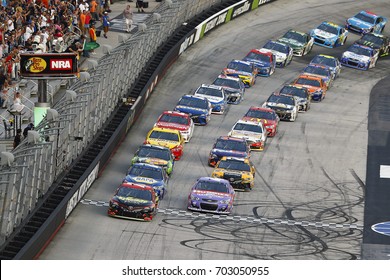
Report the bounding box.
[107,183,158,221]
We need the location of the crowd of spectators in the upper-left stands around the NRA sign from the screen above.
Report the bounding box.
[0,0,111,106]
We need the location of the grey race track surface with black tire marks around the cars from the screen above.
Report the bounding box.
[40,0,390,260]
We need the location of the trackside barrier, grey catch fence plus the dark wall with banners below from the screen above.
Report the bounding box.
[0,0,278,259]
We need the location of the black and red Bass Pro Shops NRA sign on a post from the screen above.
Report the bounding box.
[20,53,78,78]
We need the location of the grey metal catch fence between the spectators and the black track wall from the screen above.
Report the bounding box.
[0,0,227,244]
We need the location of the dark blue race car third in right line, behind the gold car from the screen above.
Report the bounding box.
[209,136,250,166]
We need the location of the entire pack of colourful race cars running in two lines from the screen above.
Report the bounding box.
[108,11,390,221]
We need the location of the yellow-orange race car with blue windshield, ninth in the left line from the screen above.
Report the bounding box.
[222,60,257,87]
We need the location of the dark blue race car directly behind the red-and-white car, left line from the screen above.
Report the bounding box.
[174,95,211,125]
